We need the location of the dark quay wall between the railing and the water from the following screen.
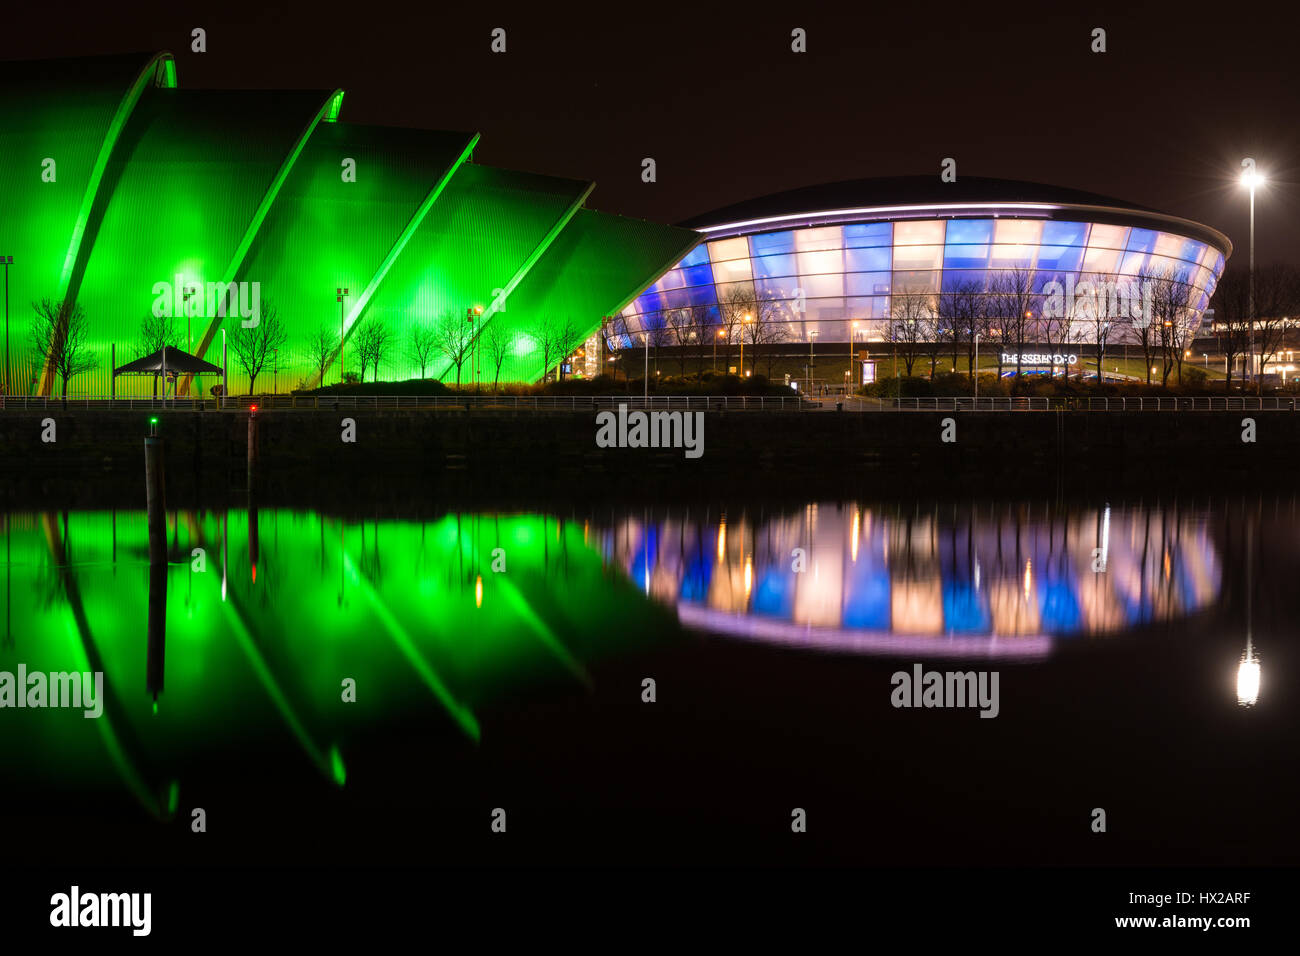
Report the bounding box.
[0,407,1300,507]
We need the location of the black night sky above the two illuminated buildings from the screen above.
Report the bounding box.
[0,1,1300,264]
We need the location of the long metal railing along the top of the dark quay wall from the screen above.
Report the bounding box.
[0,395,1300,412]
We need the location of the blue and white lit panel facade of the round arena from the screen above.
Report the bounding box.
[625,219,1223,342]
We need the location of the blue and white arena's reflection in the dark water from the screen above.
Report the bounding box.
[603,503,1221,657]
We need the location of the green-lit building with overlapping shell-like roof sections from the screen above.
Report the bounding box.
[0,53,699,395]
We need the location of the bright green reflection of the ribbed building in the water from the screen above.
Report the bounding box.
[0,511,667,817]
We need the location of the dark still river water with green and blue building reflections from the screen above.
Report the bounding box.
[0,498,1300,865]
